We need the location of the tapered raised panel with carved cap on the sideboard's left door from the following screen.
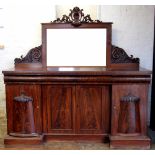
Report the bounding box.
[9,93,38,137]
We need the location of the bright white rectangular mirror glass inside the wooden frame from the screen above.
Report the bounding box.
[46,28,107,66]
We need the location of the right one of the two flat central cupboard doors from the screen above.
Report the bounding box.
[76,85,110,134]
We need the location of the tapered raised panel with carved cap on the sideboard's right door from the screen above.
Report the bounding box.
[118,93,141,134]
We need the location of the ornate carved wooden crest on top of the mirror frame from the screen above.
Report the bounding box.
[52,7,102,26]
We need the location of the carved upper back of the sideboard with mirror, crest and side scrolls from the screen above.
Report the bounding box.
[15,7,139,69]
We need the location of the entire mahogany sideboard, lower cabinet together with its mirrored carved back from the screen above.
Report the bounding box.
[3,7,151,149]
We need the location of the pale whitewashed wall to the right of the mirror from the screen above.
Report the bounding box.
[100,5,155,70]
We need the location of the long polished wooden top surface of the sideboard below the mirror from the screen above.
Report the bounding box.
[3,67,152,76]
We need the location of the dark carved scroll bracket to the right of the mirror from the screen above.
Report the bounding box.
[111,45,139,63]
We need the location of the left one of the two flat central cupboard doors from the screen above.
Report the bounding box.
[44,85,75,133]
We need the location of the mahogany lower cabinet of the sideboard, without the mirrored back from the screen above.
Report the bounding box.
[3,67,151,149]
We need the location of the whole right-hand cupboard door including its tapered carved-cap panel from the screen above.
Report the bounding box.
[111,84,148,136]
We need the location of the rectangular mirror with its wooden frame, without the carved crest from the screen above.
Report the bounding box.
[42,23,111,67]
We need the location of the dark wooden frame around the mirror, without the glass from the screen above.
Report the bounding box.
[42,22,112,67]
